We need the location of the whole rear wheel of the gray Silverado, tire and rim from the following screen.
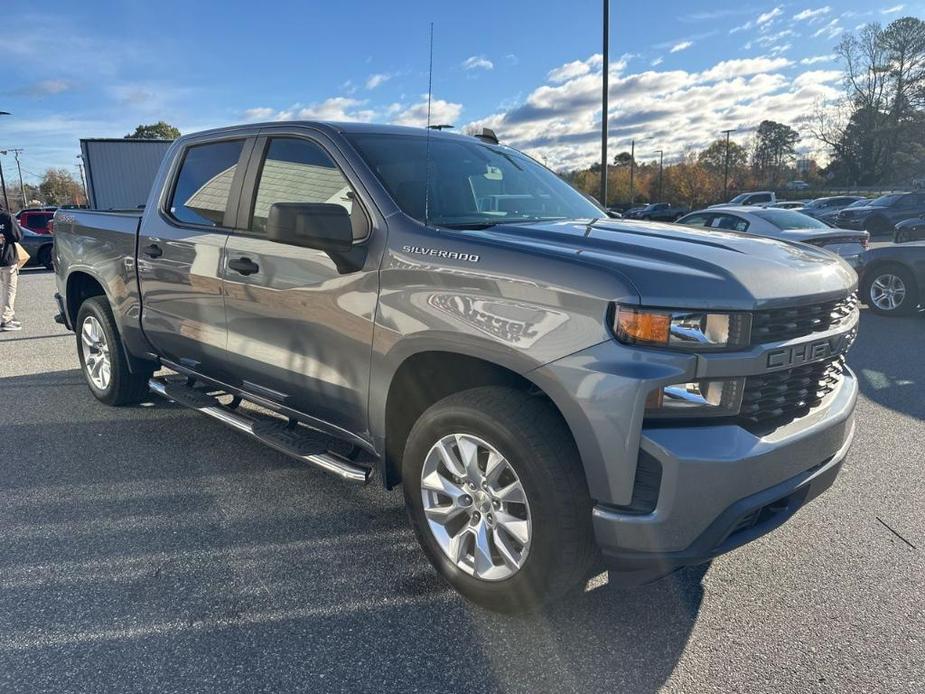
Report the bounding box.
[76,296,153,405]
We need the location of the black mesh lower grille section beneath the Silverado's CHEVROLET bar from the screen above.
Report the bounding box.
[740,356,845,425]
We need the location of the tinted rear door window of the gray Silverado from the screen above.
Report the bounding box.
[169,140,244,227]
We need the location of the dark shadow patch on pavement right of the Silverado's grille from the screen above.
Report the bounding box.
[848,310,925,419]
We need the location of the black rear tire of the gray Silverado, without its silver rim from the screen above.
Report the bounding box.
[75,296,154,406]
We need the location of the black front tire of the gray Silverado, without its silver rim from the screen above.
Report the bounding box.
[402,386,596,613]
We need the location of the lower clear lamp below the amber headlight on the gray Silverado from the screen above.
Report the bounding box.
[646,378,745,418]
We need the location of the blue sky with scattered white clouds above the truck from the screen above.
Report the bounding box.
[0,0,925,182]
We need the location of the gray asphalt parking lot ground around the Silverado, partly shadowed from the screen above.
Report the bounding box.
[0,270,925,694]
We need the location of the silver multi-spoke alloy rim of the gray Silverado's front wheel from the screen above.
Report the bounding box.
[421,434,533,581]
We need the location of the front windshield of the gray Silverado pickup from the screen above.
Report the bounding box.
[349,134,604,228]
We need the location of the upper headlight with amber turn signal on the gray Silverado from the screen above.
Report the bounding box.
[614,306,751,351]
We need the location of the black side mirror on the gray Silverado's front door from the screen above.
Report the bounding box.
[267,202,353,253]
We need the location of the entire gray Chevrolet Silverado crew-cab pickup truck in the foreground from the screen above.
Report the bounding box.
[55,122,858,611]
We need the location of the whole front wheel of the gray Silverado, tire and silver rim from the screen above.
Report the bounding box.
[402,386,595,612]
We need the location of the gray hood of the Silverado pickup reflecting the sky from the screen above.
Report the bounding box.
[473,220,857,310]
